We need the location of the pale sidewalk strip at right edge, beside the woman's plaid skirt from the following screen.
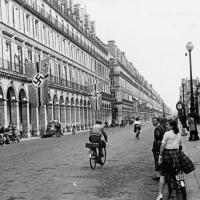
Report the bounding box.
[182,126,200,200]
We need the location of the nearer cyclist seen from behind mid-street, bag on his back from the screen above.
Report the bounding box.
[89,121,108,157]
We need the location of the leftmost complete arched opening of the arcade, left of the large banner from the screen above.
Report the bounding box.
[6,87,17,125]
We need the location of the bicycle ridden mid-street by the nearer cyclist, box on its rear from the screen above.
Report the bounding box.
[85,142,106,169]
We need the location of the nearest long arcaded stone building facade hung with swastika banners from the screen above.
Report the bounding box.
[0,0,111,137]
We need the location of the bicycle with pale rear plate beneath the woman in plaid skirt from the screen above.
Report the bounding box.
[166,168,187,200]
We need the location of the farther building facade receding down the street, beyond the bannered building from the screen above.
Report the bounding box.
[107,41,169,122]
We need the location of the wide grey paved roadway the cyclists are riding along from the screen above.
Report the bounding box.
[0,124,164,200]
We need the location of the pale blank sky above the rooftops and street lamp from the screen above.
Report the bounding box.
[74,0,200,111]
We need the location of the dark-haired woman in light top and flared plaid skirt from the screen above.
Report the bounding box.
[156,120,194,200]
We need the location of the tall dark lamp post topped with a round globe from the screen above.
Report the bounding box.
[186,42,198,140]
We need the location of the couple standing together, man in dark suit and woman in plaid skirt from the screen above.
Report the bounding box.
[152,117,195,200]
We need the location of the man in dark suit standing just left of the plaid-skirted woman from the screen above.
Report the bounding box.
[152,117,165,180]
